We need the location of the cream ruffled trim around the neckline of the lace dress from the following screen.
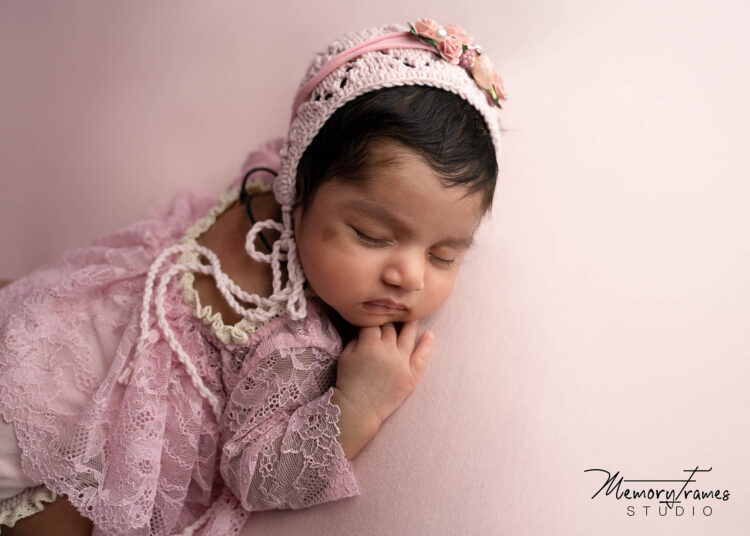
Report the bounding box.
[178,179,280,344]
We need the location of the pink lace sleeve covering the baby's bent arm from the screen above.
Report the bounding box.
[221,348,359,511]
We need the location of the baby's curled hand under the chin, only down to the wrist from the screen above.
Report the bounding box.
[336,320,434,428]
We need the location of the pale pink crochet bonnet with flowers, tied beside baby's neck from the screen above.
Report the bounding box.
[245,19,507,318]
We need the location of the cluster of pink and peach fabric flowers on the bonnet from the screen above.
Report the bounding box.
[407,19,508,108]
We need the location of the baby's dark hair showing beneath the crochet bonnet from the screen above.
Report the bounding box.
[297,86,498,212]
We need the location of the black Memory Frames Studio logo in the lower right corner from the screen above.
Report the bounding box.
[583,466,730,517]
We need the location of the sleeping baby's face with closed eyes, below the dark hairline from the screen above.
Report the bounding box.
[294,142,482,327]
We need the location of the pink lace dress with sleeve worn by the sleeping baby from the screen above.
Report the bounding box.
[0,140,359,535]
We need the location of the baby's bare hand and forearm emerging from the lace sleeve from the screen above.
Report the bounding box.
[331,321,433,460]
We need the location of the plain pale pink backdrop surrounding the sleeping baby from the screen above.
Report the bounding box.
[0,0,750,536]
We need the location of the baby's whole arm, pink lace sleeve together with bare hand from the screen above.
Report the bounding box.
[221,322,432,511]
